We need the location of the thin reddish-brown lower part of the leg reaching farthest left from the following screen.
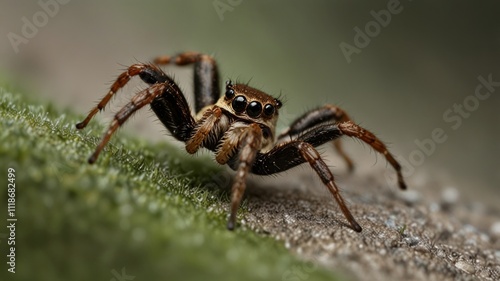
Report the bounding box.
[76,63,166,129]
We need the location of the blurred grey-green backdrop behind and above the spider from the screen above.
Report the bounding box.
[0,0,500,204]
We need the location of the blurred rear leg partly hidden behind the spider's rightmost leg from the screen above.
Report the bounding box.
[278,105,354,172]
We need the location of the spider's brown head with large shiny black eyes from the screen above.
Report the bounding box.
[217,81,282,131]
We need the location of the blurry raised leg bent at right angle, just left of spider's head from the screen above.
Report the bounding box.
[154,52,220,112]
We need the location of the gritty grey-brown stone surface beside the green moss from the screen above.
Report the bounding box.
[234,166,500,280]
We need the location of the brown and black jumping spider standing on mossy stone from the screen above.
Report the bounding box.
[76,52,406,232]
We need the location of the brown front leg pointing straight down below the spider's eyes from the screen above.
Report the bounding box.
[223,123,262,230]
